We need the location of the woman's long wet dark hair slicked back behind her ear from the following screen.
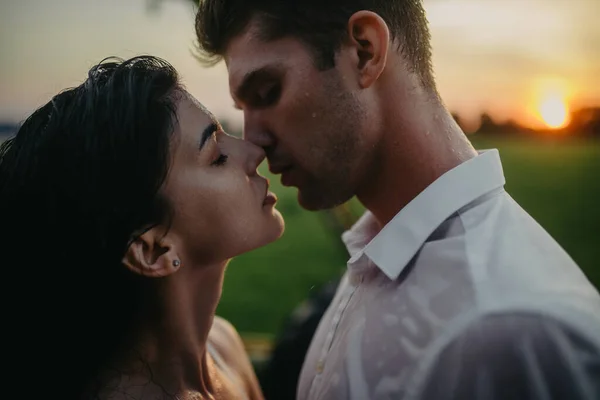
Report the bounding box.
[0,56,180,399]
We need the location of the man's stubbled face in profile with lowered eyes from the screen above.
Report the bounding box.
[225,20,375,210]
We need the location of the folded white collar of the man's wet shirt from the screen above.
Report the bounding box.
[342,149,506,279]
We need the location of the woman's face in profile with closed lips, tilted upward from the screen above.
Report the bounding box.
[162,92,284,264]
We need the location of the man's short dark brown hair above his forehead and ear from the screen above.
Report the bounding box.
[196,0,435,89]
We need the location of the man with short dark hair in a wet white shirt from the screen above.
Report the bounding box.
[196,0,600,400]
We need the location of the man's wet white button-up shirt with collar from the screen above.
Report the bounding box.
[298,150,600,400]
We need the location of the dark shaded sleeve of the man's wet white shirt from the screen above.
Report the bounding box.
[418,314,600,400]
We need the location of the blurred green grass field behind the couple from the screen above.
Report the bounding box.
[217,135,600,335]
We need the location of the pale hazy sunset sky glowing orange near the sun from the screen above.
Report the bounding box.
[0,0,600,130]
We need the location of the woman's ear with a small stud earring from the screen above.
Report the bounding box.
[123,227,181,278]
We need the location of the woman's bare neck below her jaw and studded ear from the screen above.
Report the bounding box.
[98,262,227,400]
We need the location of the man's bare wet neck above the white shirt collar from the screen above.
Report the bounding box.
[357,103,477,227]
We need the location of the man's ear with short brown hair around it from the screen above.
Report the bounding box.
[348,10,390,88]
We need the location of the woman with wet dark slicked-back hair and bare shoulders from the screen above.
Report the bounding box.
[0,56,283,400]
